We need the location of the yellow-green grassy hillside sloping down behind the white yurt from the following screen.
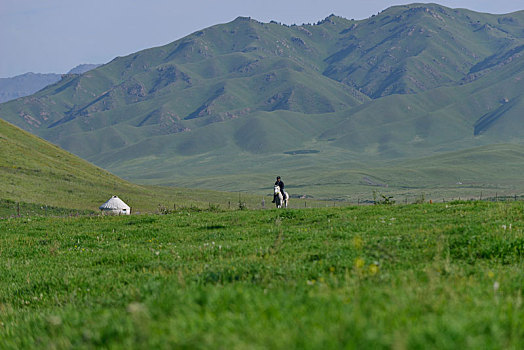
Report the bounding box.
[0,120,268,216]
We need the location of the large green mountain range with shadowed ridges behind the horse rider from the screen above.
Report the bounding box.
[0,4,524,197]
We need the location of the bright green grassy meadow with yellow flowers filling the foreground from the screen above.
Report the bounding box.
[0,202,524,349]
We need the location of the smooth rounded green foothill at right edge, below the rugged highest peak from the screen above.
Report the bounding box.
[320,56,524,158]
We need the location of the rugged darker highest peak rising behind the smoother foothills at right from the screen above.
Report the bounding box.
[325,4,524,98]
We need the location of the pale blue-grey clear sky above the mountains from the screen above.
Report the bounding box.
[0,0,524,78]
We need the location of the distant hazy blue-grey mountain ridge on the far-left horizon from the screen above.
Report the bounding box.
[0,64,100,103]
